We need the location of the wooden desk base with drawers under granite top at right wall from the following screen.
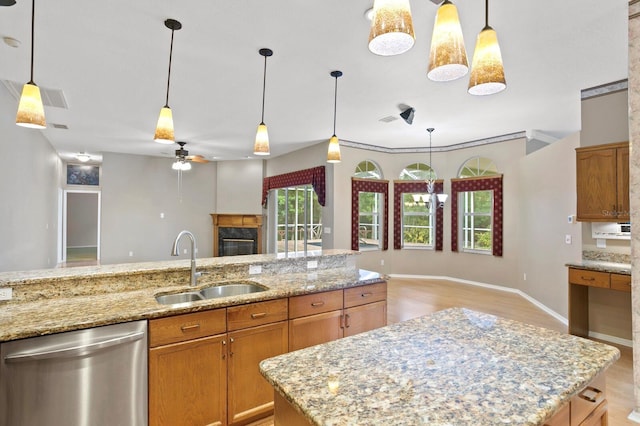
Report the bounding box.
[569,268,631,337]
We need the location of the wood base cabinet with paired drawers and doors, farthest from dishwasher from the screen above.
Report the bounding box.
[289,283,387,351]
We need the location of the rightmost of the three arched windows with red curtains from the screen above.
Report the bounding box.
[451,157,503,256]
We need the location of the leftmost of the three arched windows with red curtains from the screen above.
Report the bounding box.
[351,160,389,250]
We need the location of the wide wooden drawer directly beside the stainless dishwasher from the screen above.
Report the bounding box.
[149,309,227,347]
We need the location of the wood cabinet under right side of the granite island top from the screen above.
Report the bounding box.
[544,374,608,426]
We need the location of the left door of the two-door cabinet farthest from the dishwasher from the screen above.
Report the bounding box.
[289,308,343,351]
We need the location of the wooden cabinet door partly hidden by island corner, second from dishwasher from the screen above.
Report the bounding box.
[228,321,288,424]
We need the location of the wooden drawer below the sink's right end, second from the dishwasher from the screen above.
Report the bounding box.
[227,299,287,331]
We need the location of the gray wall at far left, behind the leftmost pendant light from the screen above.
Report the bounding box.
[0,85,62,271]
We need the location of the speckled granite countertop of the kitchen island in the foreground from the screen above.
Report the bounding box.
[260,308,620,426]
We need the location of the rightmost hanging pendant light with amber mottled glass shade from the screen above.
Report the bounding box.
[469,0,507,95]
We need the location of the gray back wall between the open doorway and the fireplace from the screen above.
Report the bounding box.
[101,153,217,264]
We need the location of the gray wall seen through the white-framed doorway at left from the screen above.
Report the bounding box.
[67,192,98,247]
